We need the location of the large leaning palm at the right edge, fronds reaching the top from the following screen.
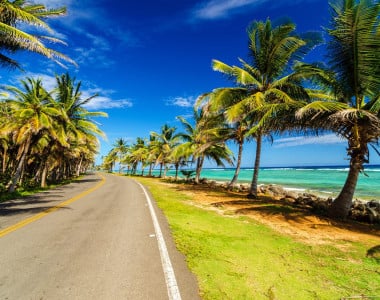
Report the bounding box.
[297,0,380,218]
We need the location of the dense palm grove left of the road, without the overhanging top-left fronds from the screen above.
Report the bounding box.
[0,74,106,192]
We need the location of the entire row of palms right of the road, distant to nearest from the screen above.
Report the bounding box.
[105,0,380,218]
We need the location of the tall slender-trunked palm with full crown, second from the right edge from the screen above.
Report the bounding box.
[210,19,319,198]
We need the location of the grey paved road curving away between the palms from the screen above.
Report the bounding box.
[0,174,199,300]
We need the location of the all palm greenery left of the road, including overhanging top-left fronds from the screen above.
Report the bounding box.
[0,0,96,192]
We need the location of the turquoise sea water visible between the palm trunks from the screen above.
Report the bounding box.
[155,165,380,199]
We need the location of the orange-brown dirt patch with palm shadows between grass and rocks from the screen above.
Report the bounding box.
[160,181,380,250]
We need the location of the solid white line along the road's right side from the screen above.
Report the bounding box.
[136,181,181,300]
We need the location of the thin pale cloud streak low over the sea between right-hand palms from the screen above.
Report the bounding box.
[273,134,345,148]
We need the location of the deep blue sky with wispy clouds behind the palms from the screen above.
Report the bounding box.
[0,0,380,167]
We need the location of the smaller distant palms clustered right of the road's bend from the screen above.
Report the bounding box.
[102,110,233,183]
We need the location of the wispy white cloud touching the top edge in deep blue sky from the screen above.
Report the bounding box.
[193,0,265,19]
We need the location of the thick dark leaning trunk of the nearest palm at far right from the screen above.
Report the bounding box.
[328,158,362,219]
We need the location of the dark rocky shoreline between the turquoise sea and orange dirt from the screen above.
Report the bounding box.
[201,179,380,224]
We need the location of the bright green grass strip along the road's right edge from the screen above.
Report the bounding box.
[138,178,380,299]
